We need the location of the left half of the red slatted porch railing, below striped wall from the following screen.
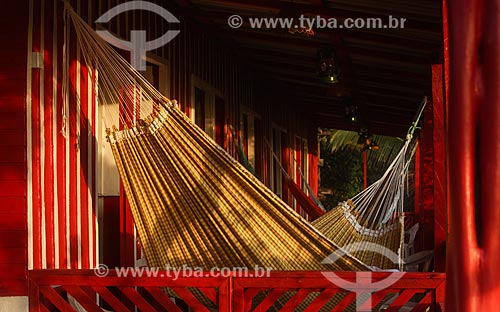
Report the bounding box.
[29,270,232,312]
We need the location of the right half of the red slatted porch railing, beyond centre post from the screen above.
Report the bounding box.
[233,271,445,312]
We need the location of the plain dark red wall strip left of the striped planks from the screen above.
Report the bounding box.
[0,0,28,296]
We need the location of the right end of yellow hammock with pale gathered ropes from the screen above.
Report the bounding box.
[312,97,427,270]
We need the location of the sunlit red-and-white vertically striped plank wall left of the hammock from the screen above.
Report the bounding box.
[27,0,98,269]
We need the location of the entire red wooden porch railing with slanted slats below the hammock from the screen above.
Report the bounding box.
[29,270,445,312]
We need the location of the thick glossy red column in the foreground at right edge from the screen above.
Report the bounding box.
[446,0,500,312]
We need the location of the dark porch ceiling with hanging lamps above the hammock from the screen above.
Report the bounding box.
[171,0,443,135]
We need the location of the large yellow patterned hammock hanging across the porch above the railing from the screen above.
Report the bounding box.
[66,1,418,270]
